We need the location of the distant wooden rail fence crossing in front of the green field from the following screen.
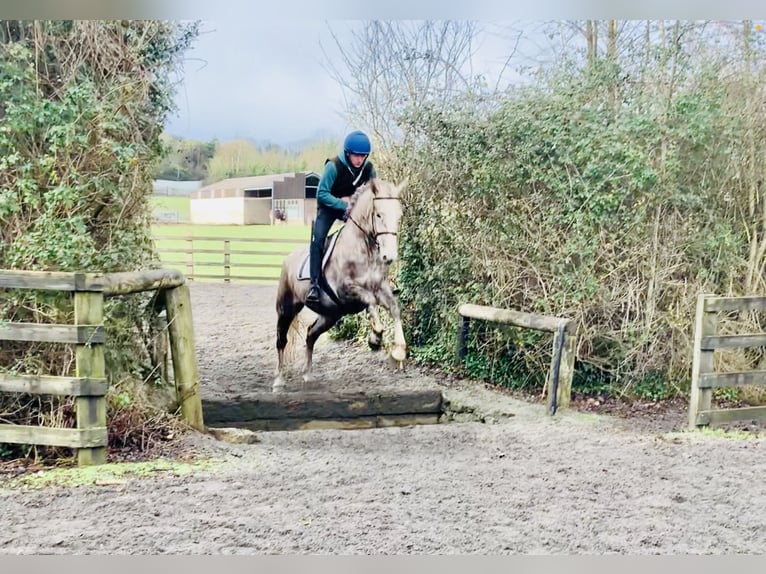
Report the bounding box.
[153,235,309,283]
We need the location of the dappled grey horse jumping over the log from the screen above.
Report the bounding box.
[272,178,407,392]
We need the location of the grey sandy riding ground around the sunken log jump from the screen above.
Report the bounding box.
[0,285,766,554]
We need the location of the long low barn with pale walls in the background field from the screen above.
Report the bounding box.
[189,171,319,225]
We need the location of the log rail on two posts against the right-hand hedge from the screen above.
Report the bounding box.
[457,303,577,415]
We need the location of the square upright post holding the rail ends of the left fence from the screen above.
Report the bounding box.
[74,292,107,466]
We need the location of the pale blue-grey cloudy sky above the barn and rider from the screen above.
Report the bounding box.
[166,18,524,147]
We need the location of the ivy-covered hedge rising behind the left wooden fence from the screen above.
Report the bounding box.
[0,21,197,452]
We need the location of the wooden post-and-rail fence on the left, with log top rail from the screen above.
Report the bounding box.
[0,270,204,465]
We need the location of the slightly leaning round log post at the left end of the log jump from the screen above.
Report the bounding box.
[165,285,205,431]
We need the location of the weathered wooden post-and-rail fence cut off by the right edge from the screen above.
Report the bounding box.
[689,294,766,429]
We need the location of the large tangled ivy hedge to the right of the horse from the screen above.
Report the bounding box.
[392,39,766,398]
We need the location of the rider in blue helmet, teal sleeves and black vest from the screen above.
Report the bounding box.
[306,131,375,303]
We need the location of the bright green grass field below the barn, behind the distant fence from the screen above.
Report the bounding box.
[152,224,311,283]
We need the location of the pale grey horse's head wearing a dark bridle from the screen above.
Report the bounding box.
[350,179,407,265]
